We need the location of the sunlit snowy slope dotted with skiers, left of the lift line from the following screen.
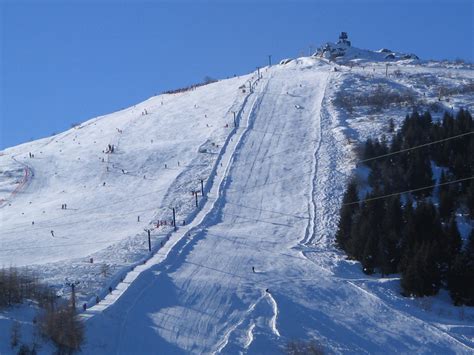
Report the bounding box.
[0,72,258,289]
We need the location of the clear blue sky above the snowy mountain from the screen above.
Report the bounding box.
[0,0,474,149]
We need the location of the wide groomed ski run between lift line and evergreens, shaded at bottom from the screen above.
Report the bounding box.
[85,59,471,354]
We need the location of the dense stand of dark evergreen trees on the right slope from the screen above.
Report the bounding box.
[336,109,474,306]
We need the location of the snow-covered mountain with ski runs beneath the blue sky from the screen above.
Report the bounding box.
[0,34,474,354]
